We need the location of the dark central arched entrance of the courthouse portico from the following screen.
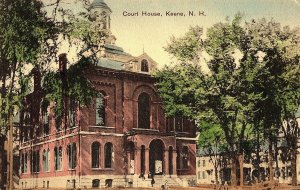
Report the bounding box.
[149,139,164,175]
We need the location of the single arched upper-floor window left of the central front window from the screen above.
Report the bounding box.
[96,92,106,126]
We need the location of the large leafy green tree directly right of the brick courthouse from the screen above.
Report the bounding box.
[156,15,260,185]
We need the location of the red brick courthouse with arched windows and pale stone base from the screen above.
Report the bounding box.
[19,0,196,188]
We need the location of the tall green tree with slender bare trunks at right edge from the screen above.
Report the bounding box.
[246,19,300,185]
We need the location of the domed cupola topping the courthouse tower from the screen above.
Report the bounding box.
[89,0,112,30]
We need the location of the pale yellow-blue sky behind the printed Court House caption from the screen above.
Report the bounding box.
[45,0,300,67]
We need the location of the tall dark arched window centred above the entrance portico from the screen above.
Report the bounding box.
[138,93,150,129]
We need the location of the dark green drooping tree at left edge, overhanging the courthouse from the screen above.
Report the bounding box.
[0,0,105,189]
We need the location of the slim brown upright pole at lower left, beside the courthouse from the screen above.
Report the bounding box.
[7,114,14,190]
